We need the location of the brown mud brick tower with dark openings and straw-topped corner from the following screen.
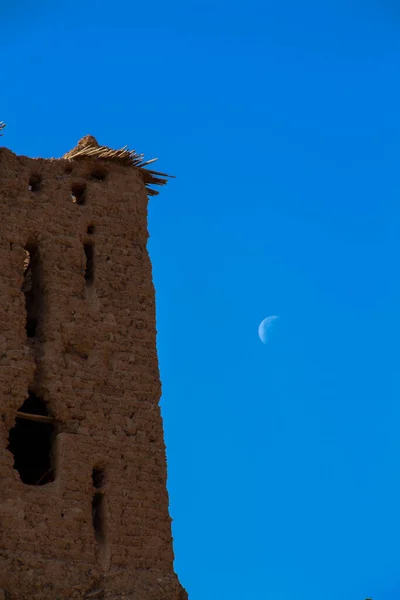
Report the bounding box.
[0,136,187,600]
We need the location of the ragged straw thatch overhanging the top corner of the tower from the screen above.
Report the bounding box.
[63,135,172,196]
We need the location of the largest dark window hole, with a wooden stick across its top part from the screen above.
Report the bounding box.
[7,392,55,485]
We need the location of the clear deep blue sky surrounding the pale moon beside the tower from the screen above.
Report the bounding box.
[0,0,400,600]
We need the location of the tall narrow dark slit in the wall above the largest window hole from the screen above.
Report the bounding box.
[22,244,43,338]
